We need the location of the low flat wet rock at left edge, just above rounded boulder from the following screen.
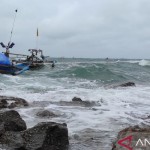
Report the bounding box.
[0,96,28,109]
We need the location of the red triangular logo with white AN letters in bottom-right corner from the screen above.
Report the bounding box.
[117,135,150,150]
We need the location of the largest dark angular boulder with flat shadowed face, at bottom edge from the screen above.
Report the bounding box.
[22,122,69,150]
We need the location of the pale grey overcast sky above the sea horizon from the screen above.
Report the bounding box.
[0,0,150,58]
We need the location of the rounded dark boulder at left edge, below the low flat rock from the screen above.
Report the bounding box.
[0,110,27,131]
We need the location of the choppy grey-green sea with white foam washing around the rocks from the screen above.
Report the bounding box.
[0,58,150,150]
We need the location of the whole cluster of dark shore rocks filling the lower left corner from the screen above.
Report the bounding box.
[0,96,69,150]
